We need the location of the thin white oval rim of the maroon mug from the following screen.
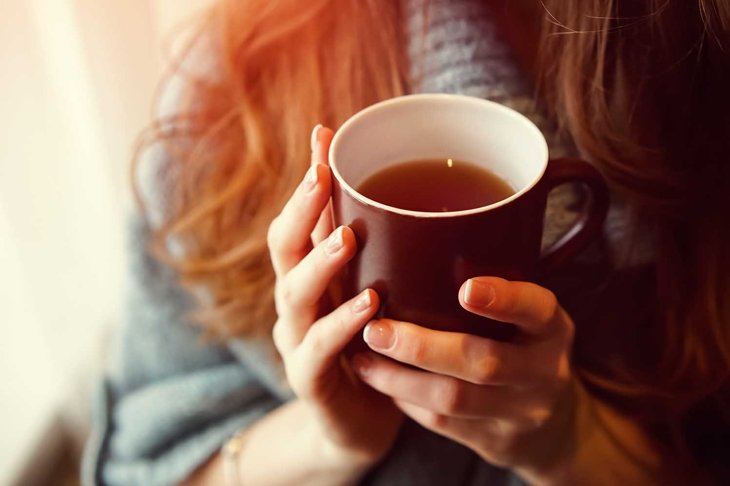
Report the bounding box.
[327,93,549,218]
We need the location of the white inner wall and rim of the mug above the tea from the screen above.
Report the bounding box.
[329,94,548,217]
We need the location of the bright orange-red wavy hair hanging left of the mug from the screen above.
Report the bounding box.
[133,0,408,338]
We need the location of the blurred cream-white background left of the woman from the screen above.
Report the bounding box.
[0,0,209,486]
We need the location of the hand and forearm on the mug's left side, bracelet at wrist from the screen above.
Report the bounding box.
[183,129,404,486]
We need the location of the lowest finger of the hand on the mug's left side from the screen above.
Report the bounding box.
[289,289,380,391]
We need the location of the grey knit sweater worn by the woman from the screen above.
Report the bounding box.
[83,0,612,486]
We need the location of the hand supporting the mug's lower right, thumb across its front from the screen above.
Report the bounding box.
[353,277,578,470]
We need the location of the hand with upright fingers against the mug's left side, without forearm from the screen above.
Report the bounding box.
[268,126,403,465]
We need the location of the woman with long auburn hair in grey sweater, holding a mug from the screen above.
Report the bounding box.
[87,0,730,485]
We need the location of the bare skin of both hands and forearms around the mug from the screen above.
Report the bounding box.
[184,127,688,486]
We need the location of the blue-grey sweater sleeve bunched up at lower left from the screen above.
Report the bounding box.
[83,219,282,486]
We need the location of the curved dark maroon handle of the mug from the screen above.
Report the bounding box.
[539,158,609,274]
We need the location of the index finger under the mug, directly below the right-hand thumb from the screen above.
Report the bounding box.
[363,319,524,385]
